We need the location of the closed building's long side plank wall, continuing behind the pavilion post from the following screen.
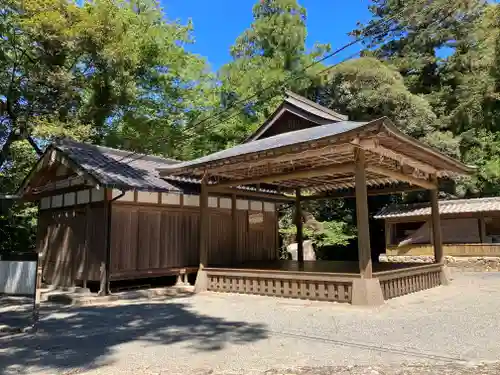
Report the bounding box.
[111,203,277,280]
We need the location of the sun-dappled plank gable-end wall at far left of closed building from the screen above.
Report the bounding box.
[37,203,106,286]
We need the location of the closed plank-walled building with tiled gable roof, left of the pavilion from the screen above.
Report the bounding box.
[19,139,290,294]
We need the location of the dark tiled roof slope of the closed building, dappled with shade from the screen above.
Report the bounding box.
[53,139,195,191]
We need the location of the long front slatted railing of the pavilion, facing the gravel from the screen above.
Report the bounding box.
[206,268,358,303]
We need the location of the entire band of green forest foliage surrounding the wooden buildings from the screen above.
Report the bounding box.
[0,0,500,256]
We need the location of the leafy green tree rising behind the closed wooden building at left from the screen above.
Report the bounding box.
[0,0,212,253]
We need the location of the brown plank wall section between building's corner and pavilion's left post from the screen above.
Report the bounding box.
[111,204,199,280]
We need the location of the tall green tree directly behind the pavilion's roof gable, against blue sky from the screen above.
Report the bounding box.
[193,0,330,153]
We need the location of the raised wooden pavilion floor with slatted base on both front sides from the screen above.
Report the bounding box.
[205,260,441,303]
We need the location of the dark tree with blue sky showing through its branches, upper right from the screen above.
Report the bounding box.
[351,0,486,94]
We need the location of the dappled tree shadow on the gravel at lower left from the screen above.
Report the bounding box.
[0,298,268,374]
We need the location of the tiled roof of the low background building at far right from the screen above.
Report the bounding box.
[374,197,500,219]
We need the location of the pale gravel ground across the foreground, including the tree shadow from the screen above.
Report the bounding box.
[0,273,500,375]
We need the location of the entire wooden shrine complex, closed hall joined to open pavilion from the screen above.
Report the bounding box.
[20,93,472,305]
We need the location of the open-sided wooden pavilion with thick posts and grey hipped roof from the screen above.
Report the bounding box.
[159,94,472,305]
